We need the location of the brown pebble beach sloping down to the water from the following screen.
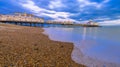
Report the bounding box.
[0,24,85,67]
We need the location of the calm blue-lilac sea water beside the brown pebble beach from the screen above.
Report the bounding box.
[44,26,120,67]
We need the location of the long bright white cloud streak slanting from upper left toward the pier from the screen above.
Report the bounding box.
[20,0,73,19]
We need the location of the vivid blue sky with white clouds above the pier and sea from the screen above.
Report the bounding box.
[0,0,120,25]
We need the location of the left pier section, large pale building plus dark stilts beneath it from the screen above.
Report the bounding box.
[0,13,44,26]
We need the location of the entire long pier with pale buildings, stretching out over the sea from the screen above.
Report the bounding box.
[0,13,98,27]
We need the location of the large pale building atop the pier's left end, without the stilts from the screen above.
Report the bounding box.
[0,13,44,23]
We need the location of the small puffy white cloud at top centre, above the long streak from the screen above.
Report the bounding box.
[48,0,65,9]
